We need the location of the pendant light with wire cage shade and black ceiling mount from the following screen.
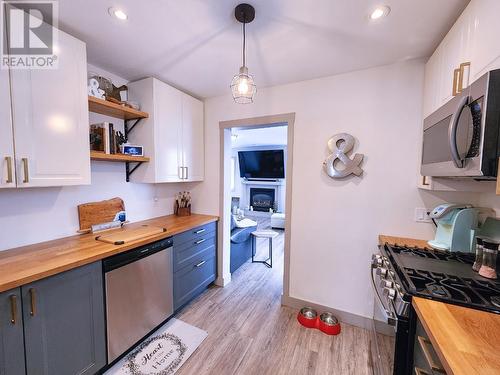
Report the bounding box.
[231,4,257,104]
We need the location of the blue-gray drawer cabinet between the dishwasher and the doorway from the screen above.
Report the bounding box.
[173,223,217,311]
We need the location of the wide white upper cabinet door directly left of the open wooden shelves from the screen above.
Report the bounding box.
[11,26,90,187]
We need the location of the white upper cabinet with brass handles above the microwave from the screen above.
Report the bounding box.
[423,0,500,117]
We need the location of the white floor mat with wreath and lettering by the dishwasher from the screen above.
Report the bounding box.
[105,319,208,375]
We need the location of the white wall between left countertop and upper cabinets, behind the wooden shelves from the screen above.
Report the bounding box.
[0,65,196,250]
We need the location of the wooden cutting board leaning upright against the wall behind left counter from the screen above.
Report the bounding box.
[78,198,125,232]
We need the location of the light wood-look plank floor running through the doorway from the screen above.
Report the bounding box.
[176,220,372,375]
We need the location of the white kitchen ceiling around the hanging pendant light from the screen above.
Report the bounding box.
[54,0,468,97]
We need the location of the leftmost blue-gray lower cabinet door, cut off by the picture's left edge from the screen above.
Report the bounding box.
[0,288,26,375]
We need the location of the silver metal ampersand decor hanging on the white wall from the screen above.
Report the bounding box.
[323,133,364,179]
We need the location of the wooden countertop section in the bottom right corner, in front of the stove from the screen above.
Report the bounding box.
[412,297,500,375]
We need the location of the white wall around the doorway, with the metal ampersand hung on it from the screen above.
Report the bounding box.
[194,61,477,317]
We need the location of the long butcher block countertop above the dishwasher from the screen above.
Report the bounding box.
[0,214,219,292]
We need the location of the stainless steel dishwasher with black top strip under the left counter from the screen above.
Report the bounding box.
[103,237,174,363]
